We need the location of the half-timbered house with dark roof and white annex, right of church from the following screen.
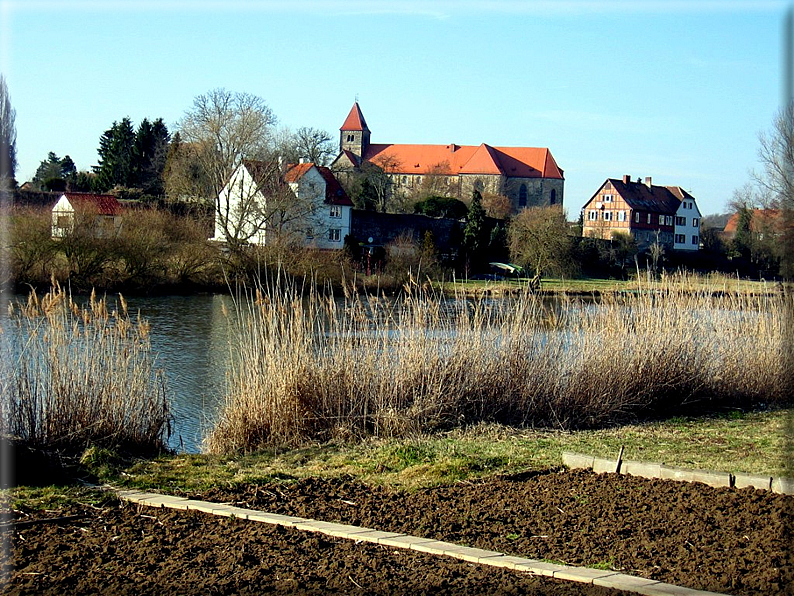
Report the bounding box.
[582,176,701,251]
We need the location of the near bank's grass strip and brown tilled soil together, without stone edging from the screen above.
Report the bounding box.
[0,409,794,596]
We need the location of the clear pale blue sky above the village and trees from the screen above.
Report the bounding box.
[0,0,791,219]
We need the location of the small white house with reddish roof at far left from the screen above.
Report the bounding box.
[52,192,122,238]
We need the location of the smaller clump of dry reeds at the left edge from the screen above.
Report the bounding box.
[0,284,171,455]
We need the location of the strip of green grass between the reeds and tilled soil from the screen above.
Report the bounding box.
[100,409,794,492]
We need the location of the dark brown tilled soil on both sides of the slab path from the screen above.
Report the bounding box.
[0,471,794,595]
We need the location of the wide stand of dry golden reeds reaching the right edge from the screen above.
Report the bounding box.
[205,272,794,452]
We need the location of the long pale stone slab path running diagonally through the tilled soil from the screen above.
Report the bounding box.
[116,490,725,596]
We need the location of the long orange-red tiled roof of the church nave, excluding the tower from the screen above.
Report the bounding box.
[363,143,563,179]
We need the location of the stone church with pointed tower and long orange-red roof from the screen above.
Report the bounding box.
[331,102,565,213]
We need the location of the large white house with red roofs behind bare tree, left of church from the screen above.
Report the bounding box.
[211,160,353,249]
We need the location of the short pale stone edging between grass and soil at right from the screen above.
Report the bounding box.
[562,451,794,495]
